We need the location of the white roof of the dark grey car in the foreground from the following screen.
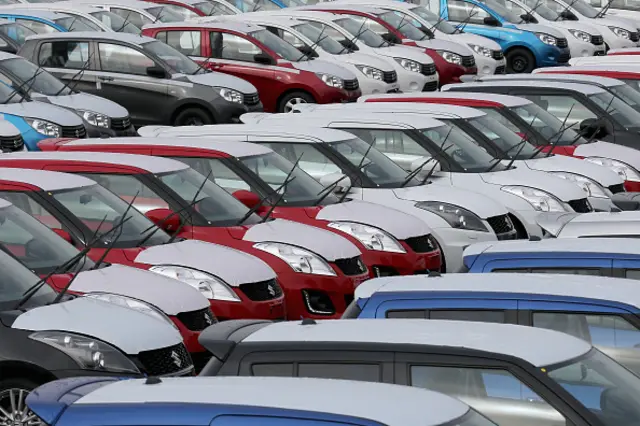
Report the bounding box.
[243,318,591,367]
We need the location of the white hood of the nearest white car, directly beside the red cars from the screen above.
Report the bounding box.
[393,180,508,219]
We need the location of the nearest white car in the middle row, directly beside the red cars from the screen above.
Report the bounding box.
[140,120,524,272]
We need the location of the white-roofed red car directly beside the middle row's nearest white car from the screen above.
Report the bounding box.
[37,137,441,277]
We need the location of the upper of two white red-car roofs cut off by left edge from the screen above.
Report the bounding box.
[0,151,189,173]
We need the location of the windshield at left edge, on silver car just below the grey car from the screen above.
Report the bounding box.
[0,57,73,98]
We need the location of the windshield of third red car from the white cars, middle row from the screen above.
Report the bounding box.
[51,185,170,248]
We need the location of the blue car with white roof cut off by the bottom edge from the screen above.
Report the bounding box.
[26,377,495,426]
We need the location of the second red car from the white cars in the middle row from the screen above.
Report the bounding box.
[0,148,369,319]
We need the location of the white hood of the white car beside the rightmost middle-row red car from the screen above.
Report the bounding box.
[516,155,624,187]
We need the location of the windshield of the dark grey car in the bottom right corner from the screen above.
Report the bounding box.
[542,349,640,426]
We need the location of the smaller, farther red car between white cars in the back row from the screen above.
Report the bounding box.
[304,2,478,86]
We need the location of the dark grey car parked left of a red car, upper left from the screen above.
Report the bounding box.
[18,32,262,127]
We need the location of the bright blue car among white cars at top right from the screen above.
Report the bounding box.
[430,0,571,73]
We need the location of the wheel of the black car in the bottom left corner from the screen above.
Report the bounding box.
[0,379,46,426]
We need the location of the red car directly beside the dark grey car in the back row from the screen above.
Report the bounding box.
[142,22,361,112]
